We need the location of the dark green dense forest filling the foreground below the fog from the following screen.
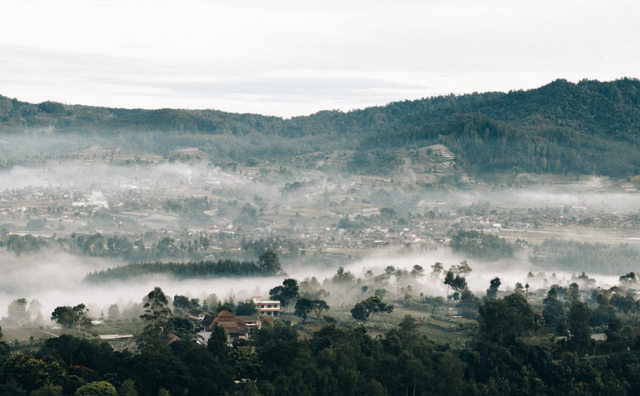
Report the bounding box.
[0,278,640,396]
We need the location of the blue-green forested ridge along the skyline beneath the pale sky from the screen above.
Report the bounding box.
[0,78,640,177]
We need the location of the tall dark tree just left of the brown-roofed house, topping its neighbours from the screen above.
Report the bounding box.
[140,287,172,348]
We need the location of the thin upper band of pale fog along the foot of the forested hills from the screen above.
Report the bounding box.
[0,161,640,213]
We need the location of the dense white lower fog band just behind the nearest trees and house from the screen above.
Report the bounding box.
[0,249,617,322]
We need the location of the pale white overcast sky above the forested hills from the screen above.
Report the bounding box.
[0,0,640,117]
